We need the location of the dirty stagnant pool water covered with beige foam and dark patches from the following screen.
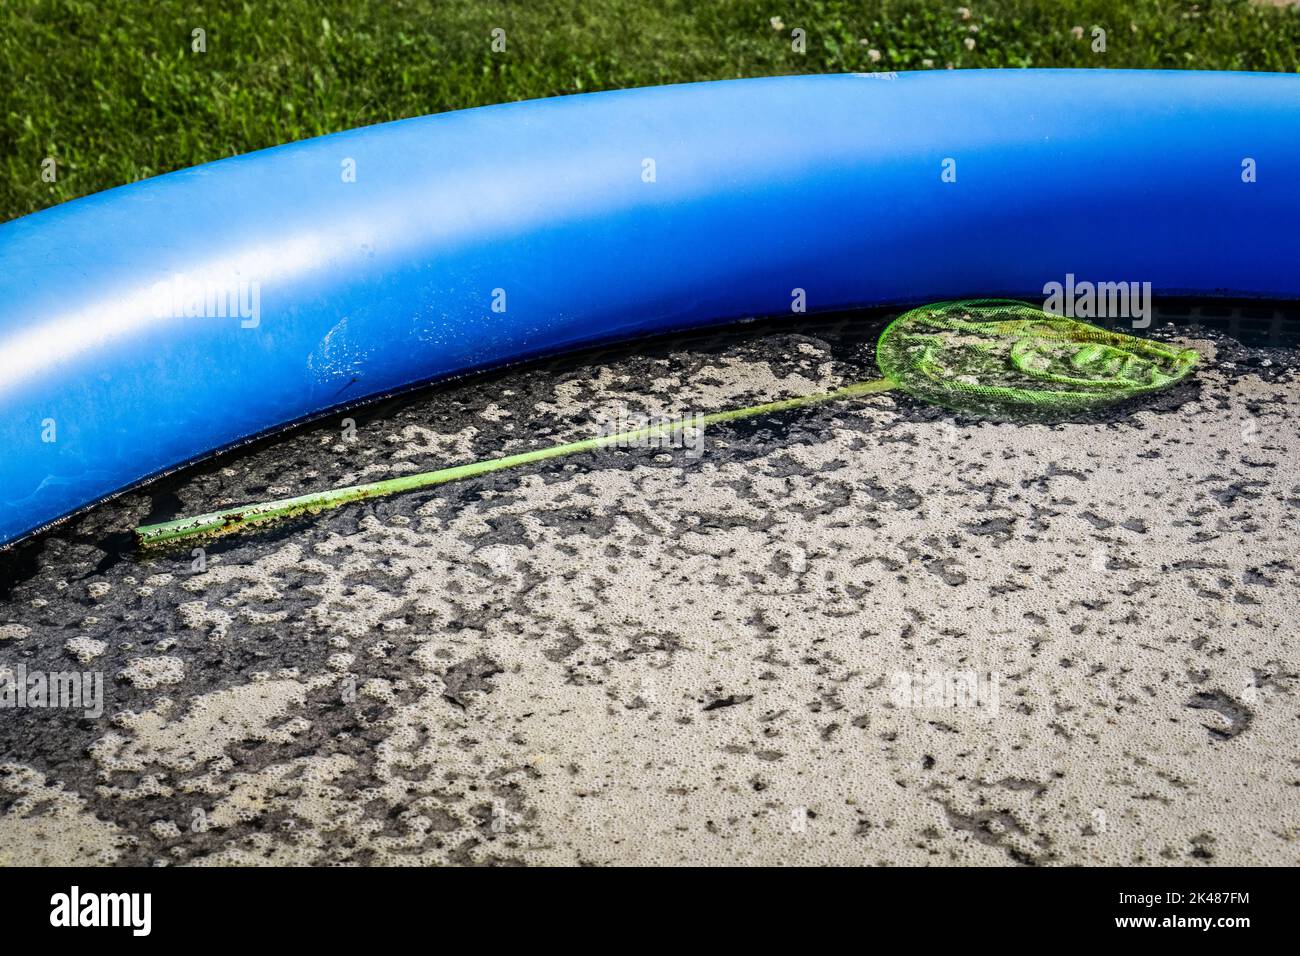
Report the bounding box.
[0,303,1300,864]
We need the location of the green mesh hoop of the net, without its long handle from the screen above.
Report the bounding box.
[876,299,1196,418]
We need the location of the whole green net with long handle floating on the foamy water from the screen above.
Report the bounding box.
[135,299,1196,546]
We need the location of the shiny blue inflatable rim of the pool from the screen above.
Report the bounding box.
[0,70,1300,545]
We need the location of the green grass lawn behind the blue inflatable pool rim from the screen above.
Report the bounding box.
[0,0,1300,219]
